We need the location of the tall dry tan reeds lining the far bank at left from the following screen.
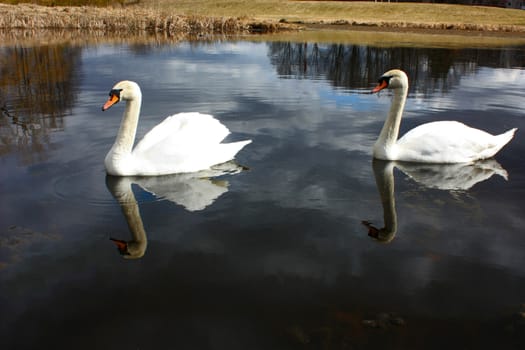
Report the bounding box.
[0,4,289,35]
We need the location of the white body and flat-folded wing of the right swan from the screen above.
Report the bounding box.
[397,121,512,163]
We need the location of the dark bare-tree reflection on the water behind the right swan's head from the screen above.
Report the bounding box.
[268,42,525,95]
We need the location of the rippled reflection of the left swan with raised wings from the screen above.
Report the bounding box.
[106,161,247,259]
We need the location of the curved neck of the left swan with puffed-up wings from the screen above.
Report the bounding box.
[112,94,142,154]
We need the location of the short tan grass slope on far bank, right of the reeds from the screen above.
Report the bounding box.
[145,0,525,31]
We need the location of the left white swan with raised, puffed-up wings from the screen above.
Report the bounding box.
[102,80,251,176]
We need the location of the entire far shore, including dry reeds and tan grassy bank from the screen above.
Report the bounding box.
[0,0,525,33]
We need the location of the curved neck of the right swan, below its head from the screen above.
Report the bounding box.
[374,87,408,159]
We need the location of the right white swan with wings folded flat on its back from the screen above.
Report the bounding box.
[372,69,516,163]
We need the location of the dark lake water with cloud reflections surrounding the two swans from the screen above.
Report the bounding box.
[0,37,525,349]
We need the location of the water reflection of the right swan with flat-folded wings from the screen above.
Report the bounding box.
[362,159,508,243]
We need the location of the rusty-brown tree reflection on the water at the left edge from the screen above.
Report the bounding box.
[0,44,81,164]
